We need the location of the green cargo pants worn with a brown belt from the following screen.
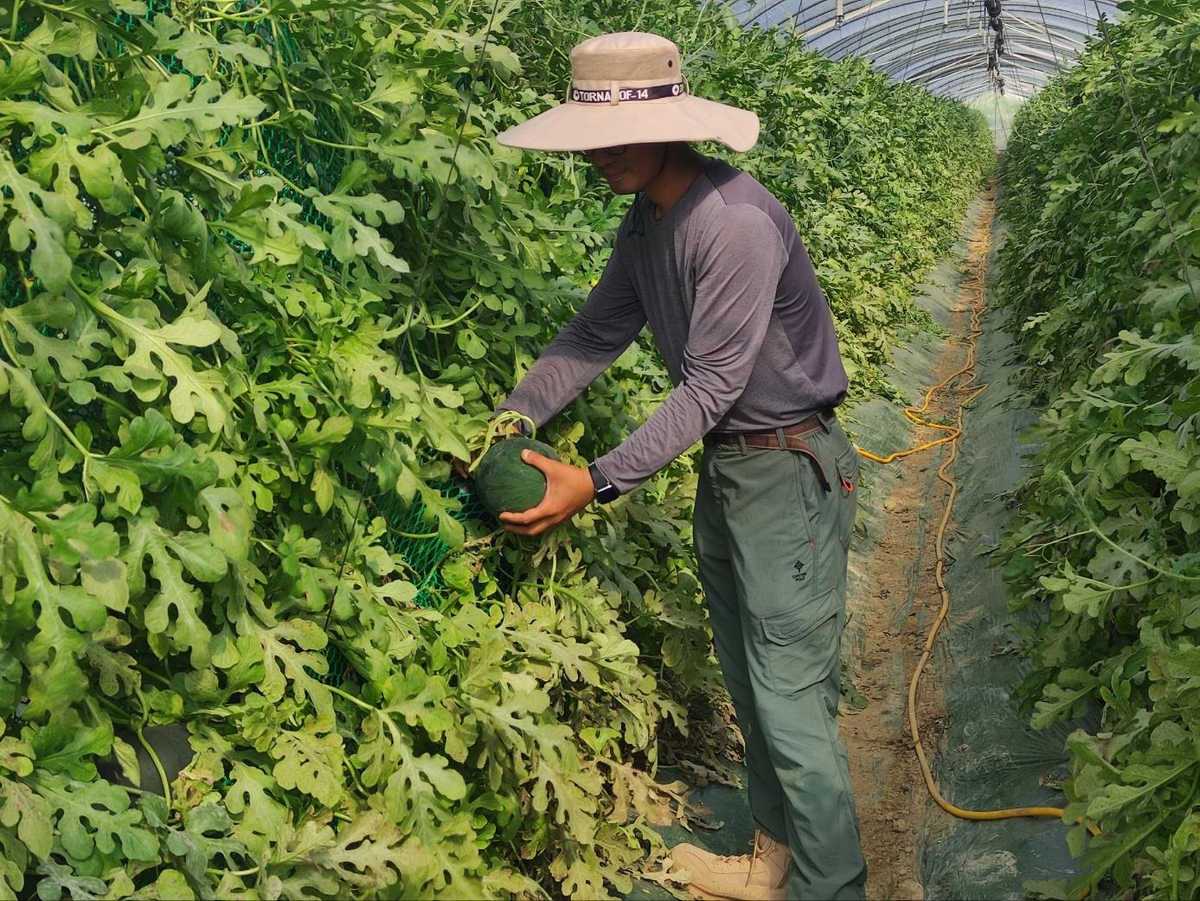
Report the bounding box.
[694,415,866,900]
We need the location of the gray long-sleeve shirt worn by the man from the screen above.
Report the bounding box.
[499,161,846,493]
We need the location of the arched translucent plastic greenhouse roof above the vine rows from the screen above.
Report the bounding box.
[727,0,1117,101]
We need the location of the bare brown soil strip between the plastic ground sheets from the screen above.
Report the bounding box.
[840,190,995,901]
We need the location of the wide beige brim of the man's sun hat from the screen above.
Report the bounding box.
[496,95,758,154]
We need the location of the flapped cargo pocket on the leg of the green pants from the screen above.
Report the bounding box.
[758,589,841,695]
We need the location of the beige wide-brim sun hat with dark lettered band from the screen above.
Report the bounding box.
[497,31,758,152]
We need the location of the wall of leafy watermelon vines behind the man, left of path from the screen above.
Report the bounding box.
[0,0,990,899]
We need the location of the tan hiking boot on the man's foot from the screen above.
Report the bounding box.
[671,829,792,901]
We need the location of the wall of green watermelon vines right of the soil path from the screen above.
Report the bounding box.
[1001,0,1200,897]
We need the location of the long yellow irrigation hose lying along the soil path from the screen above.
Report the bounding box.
[858,196,1099,835]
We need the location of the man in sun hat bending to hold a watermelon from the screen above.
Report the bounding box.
[498,32,866,899]
